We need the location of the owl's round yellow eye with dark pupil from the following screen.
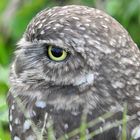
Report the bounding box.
[47,46,68,62]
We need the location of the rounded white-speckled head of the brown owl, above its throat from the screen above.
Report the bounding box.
[11,5,139,95]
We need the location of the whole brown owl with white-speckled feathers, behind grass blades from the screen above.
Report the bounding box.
[7,5,140,140]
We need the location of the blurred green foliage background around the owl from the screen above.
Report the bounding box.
[0,0,140,140]
